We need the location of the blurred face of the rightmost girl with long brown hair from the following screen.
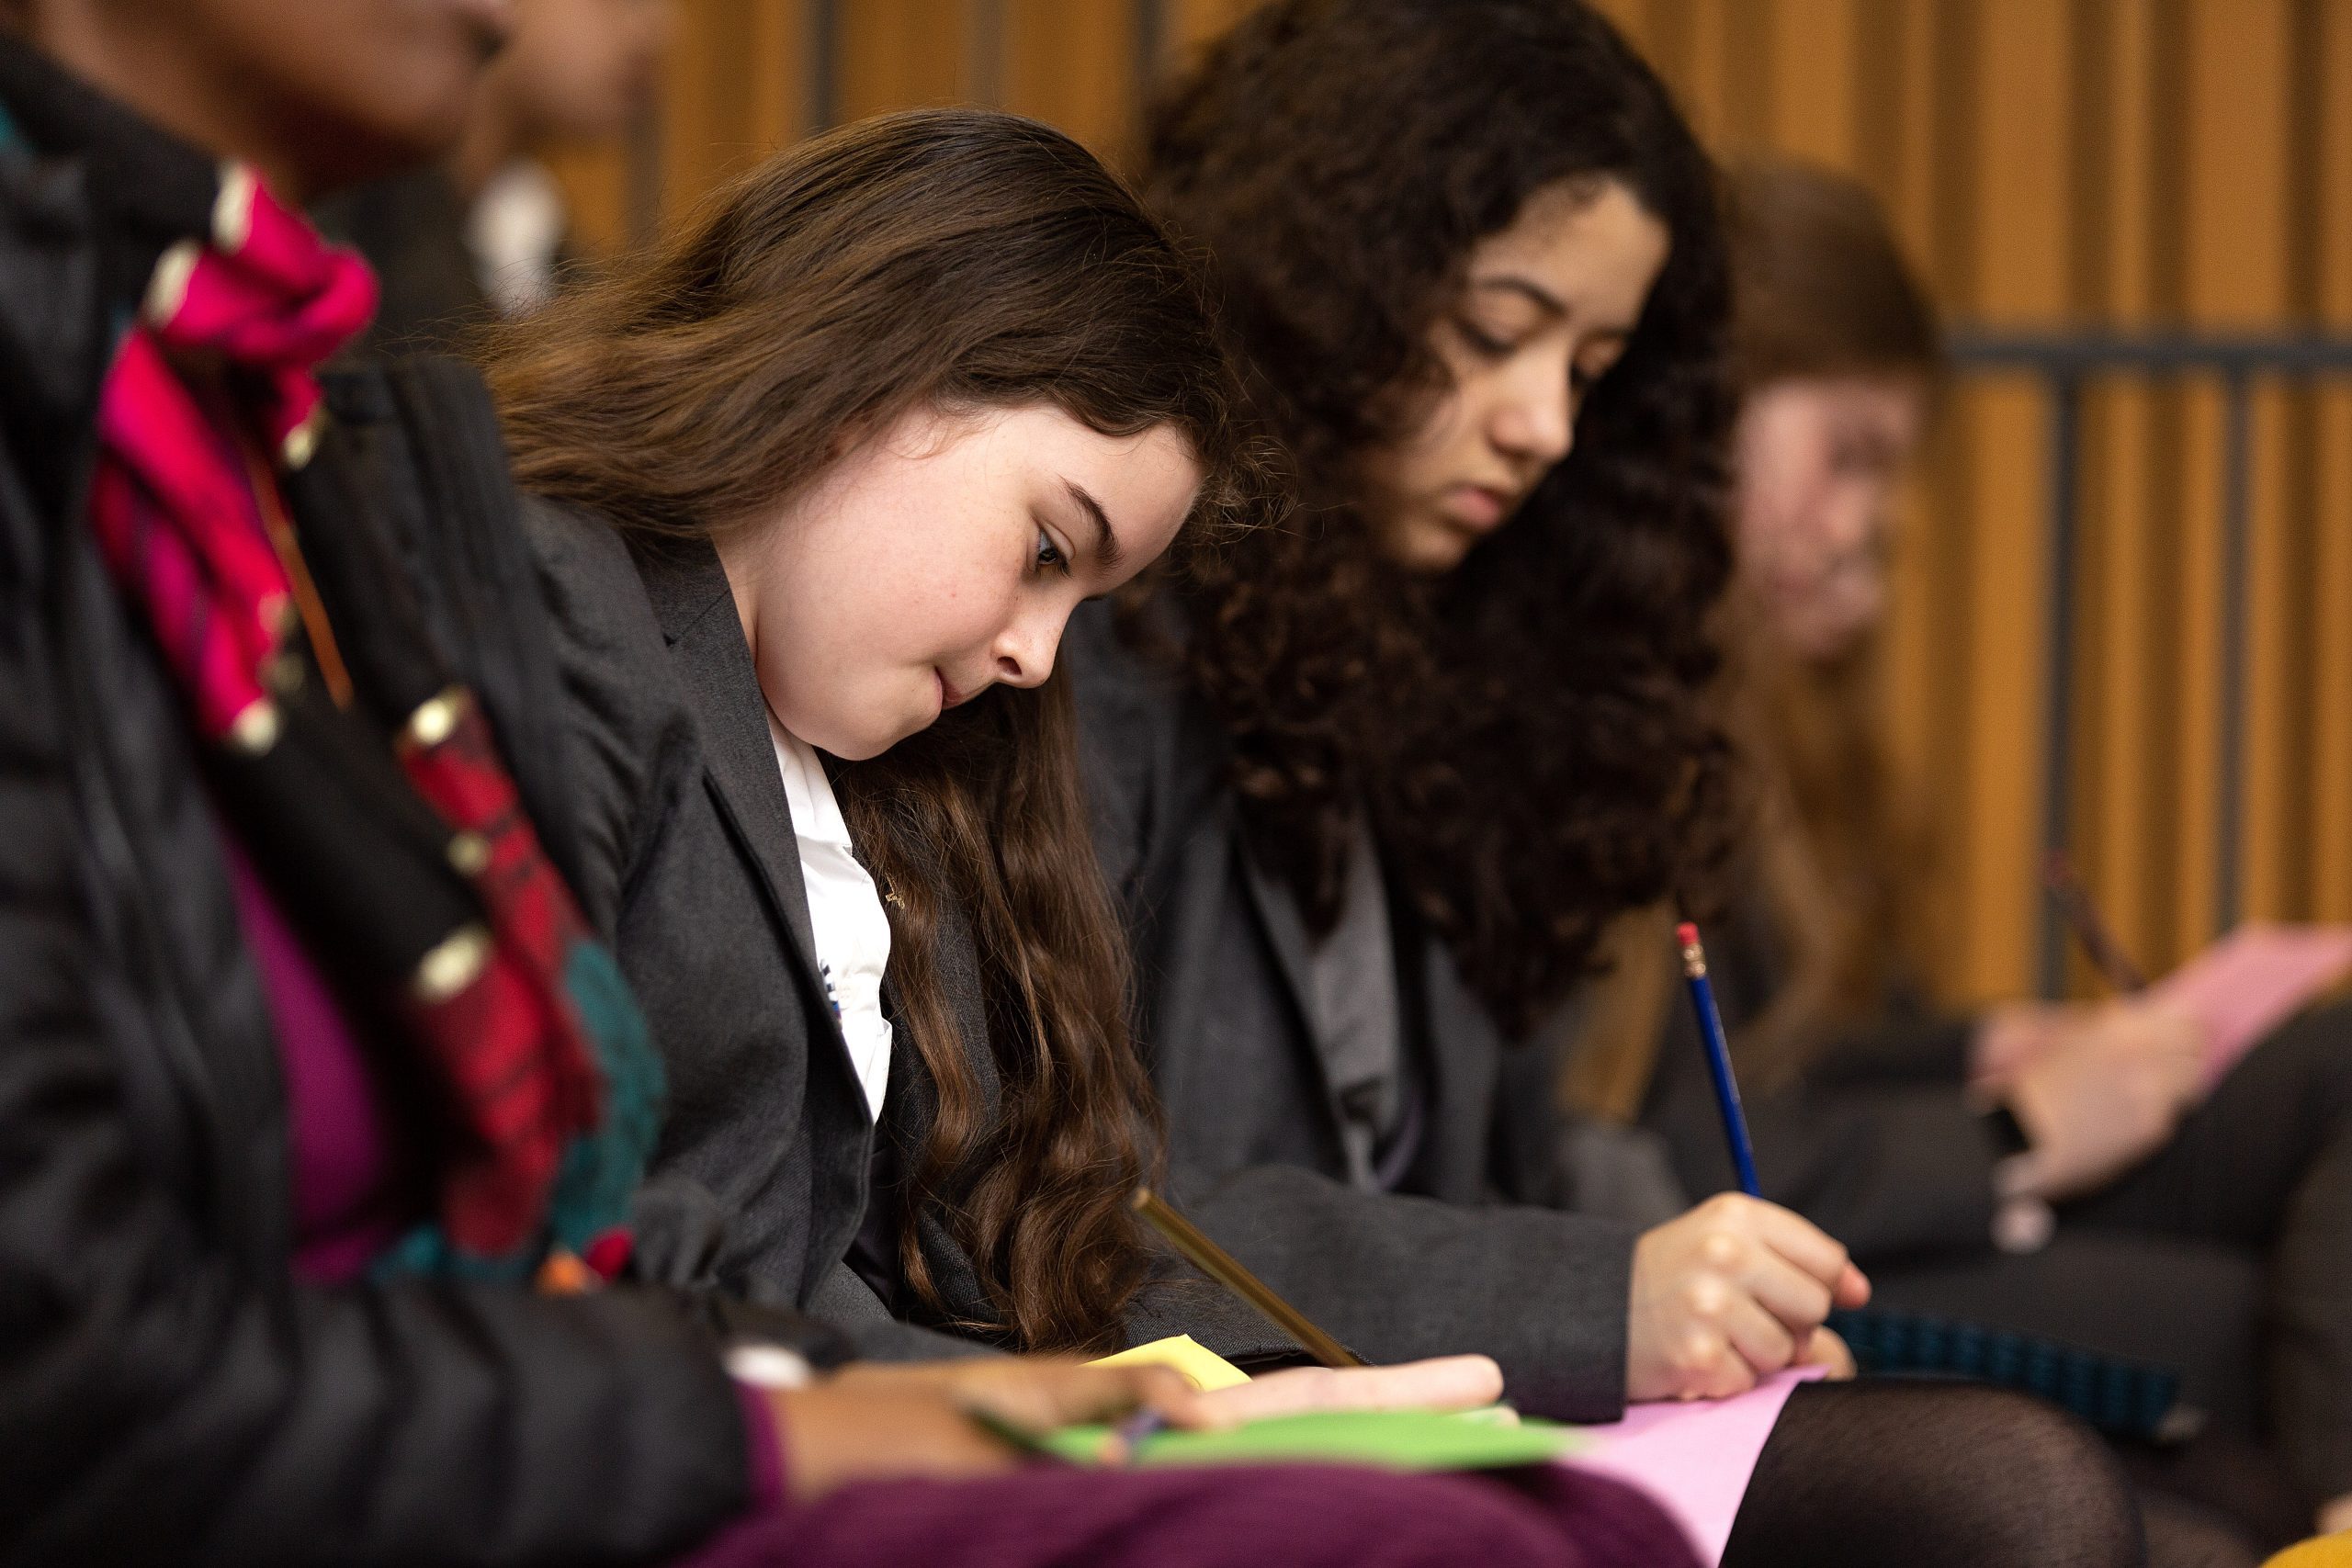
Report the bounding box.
[1738,376,1927,660]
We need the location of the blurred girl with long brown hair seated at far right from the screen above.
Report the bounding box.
[1571,164,2352,1538]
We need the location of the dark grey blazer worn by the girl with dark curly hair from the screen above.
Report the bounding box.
[1063,604,1634,1420]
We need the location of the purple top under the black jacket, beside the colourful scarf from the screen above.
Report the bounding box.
[228,841,412,1283]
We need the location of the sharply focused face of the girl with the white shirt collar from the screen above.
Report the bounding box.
[719,407,1202,761]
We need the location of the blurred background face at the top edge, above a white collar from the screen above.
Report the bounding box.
[492,0,673,141]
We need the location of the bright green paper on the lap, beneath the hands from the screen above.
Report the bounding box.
[1042,1411,1585,1470]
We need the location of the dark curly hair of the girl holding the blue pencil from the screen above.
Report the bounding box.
[1146,0,1734,1034]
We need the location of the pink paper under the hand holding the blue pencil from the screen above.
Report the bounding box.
[1566,1366,1823,1563]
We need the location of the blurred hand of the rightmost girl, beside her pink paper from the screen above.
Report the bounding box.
[2004,1001,2204,1201]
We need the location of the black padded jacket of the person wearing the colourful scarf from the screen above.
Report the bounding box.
[0,40,780,1565]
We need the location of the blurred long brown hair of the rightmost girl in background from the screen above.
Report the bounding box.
[1564,163,1943,1122]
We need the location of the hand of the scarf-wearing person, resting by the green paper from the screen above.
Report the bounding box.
[769,1357,1206,1502]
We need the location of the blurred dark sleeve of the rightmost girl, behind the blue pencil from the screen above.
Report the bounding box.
[1642,997,2002,1265]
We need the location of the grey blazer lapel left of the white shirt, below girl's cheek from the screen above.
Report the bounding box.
[638,541,847,1043]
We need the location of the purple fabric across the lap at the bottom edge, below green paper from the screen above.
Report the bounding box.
[689,1464,1698,1568]
